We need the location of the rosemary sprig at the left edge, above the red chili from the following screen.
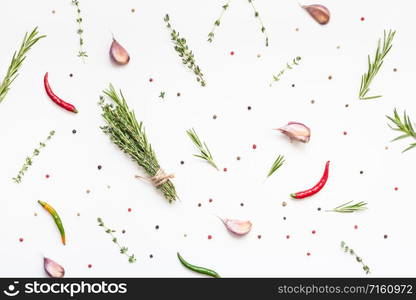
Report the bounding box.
[0,27,46,103]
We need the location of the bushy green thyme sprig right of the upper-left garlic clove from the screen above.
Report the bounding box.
[163,14,206,86]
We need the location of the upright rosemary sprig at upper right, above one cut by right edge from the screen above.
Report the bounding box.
[359,30,396,100]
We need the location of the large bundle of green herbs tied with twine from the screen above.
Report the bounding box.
[99,84,177,202]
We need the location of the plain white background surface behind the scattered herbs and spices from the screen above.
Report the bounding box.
[0,0,416,277]
